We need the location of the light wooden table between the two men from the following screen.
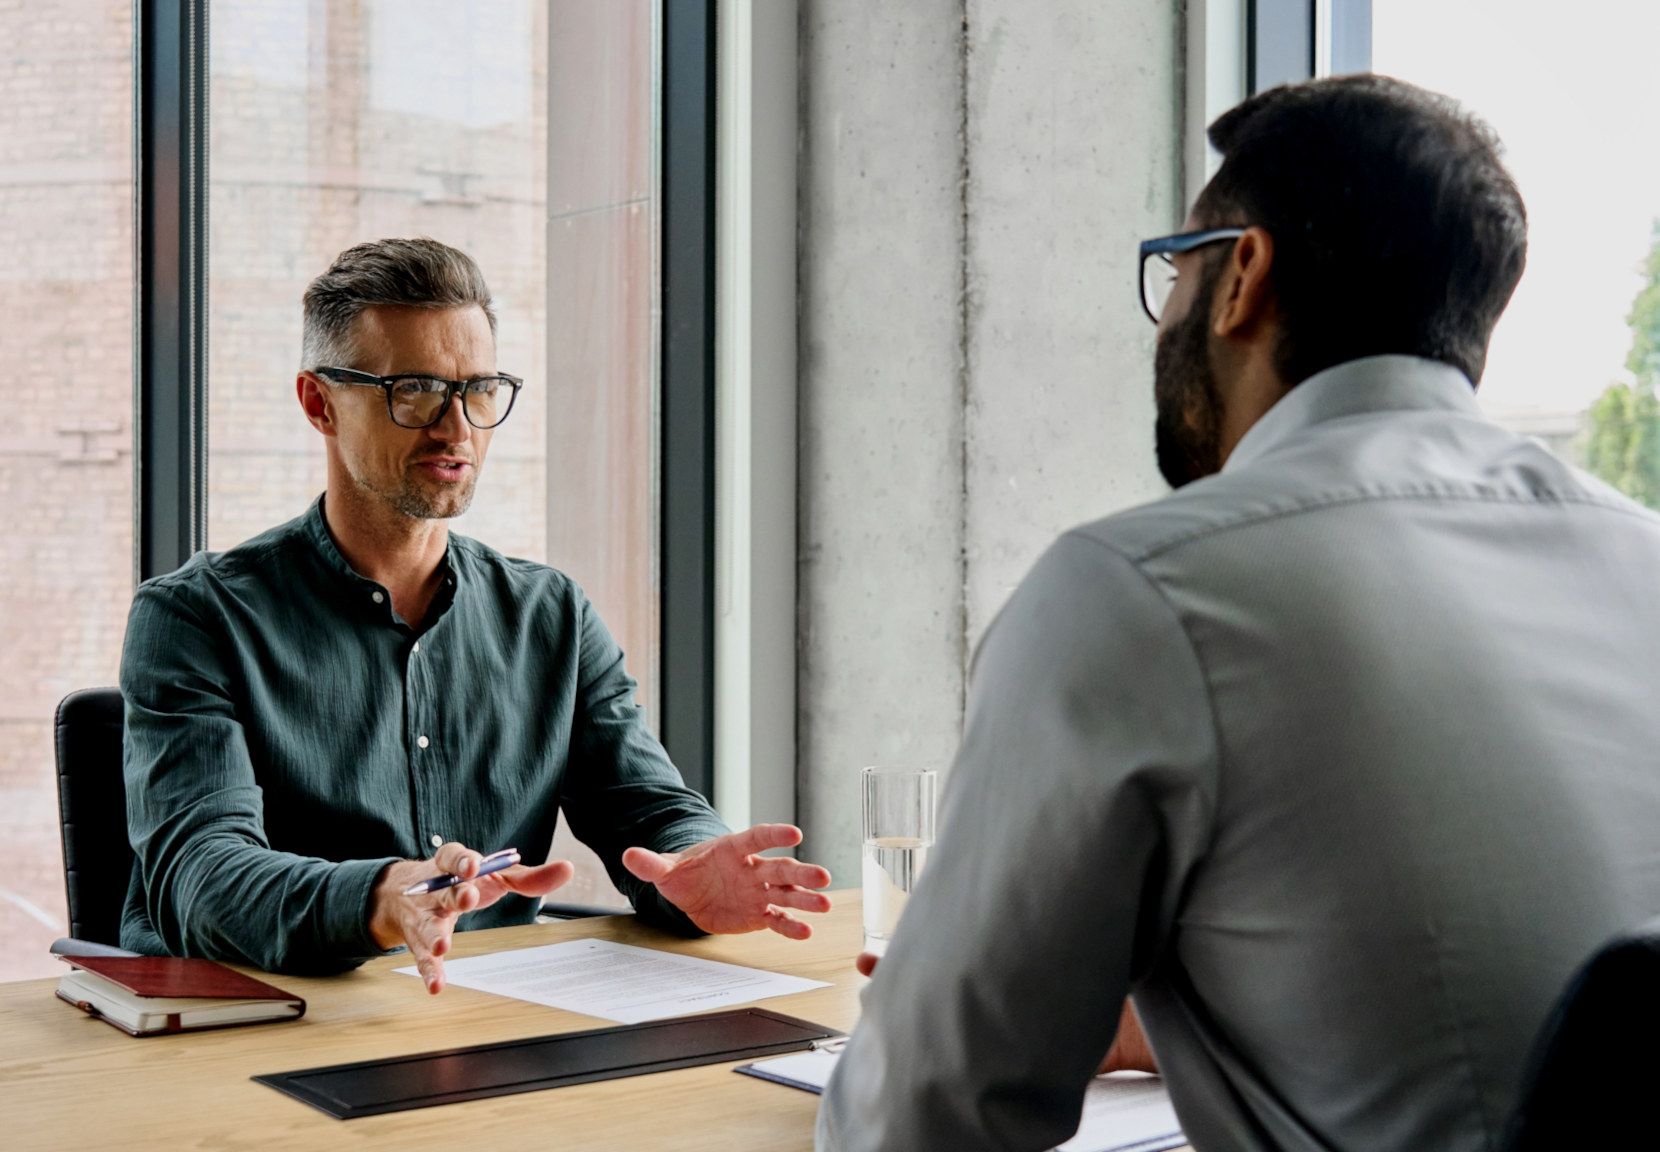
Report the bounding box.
[0,891,865,1152]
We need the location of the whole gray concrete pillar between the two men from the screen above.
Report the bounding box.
[797,0,1184,885]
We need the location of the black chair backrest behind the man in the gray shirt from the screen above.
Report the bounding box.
[1504,920,1660,1152]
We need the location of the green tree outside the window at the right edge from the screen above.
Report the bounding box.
[1585,221,1660,508]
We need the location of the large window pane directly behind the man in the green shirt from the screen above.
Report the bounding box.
[208,0,657,922]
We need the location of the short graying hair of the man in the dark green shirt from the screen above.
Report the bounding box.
[300,236,496,370]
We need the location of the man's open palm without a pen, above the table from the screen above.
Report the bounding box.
[623,823,830,940]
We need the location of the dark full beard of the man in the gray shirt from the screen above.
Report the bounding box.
[1152,264,1222,488]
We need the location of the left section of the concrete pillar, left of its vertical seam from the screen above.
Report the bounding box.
[797,0,963,883]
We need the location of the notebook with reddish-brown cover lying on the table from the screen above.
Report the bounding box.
[58,956,305,1036]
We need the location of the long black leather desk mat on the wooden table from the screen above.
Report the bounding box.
[254,1008,840,1120]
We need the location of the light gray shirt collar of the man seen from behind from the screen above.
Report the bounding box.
[1222,355,1481,471]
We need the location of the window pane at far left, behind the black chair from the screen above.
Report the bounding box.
[0,0,133,979]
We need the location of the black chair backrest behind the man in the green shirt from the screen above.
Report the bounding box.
[56,687,133,945]
